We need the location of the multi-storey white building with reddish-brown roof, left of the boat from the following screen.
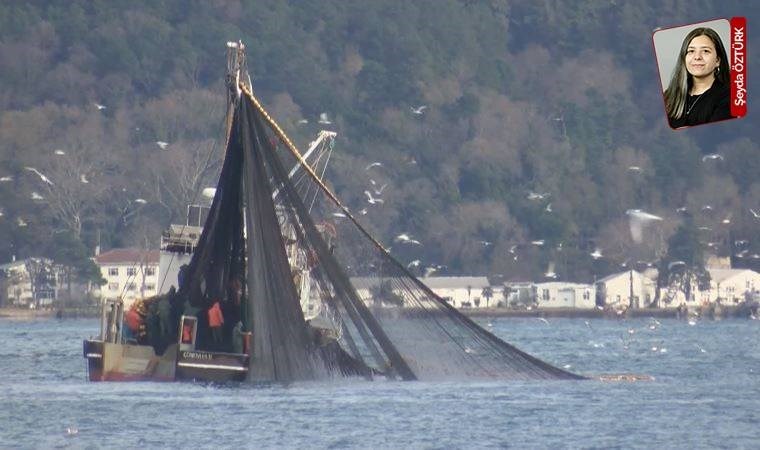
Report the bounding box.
[95,248,160,309]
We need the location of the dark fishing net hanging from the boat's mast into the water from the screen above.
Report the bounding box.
[177,92,581,382]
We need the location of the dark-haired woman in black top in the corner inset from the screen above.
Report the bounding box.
[665,27,732,128]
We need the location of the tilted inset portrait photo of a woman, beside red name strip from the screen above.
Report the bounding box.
[652,19,735,129]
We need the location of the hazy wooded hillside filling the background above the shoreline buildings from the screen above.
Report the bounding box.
[0,0,760,281]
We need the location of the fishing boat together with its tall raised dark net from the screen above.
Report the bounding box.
[84,42,584,383]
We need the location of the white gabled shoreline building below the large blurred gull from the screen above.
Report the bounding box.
[596,270,657,308]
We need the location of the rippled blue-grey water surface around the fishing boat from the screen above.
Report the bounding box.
[0,319,760,448]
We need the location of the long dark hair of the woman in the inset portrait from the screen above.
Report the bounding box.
[665,27,728,119]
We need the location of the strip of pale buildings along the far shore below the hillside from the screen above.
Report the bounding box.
[0,244,760,318]
